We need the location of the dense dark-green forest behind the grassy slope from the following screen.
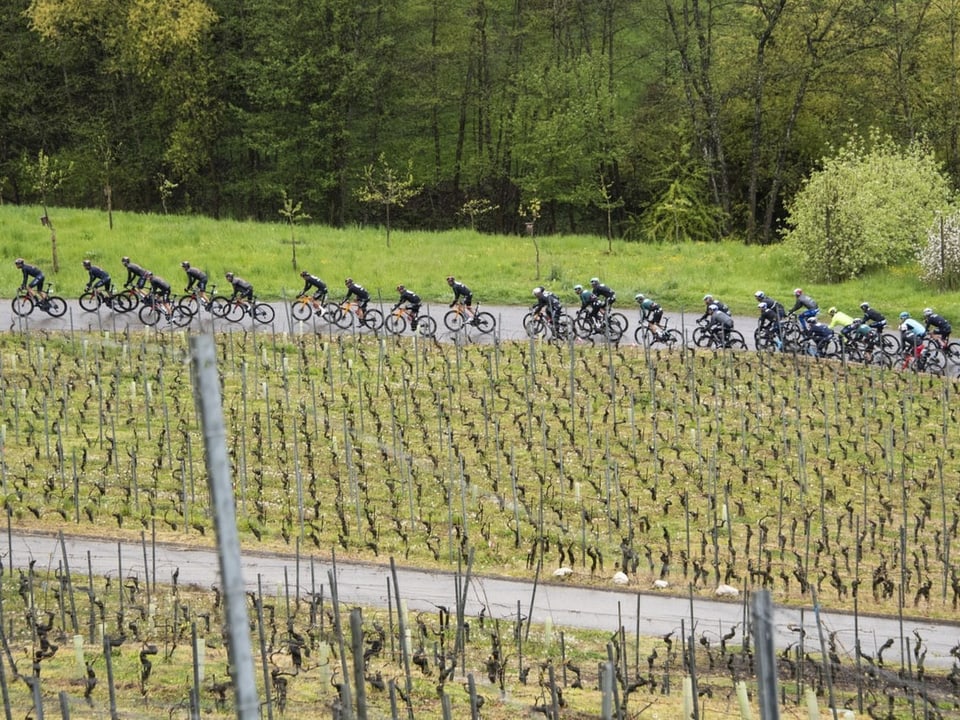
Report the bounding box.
[0,0,960,243]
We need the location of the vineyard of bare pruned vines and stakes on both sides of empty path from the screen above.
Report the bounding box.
[0,332,960,717]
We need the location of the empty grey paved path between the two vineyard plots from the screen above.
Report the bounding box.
[9,533,960,667]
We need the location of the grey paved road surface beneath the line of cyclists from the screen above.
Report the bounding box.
[0,300,757,347]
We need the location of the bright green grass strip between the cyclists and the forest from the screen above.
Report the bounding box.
[0,206,960,318]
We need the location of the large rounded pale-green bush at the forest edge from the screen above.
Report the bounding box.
[786,130,950,282]
